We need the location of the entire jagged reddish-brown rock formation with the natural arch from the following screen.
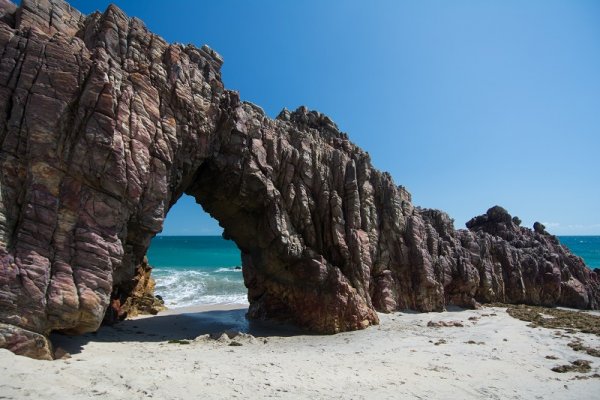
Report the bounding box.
[0,0,600,357]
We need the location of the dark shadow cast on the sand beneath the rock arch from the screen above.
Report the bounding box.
[50,308,307,354]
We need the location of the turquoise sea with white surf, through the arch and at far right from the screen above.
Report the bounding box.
[148,236,600,308]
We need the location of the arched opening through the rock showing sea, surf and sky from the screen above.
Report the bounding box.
[147,194,248,308]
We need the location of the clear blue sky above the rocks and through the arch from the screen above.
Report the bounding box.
[71,0,600,235]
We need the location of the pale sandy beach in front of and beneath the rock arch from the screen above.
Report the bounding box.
[0,306,600,399]
